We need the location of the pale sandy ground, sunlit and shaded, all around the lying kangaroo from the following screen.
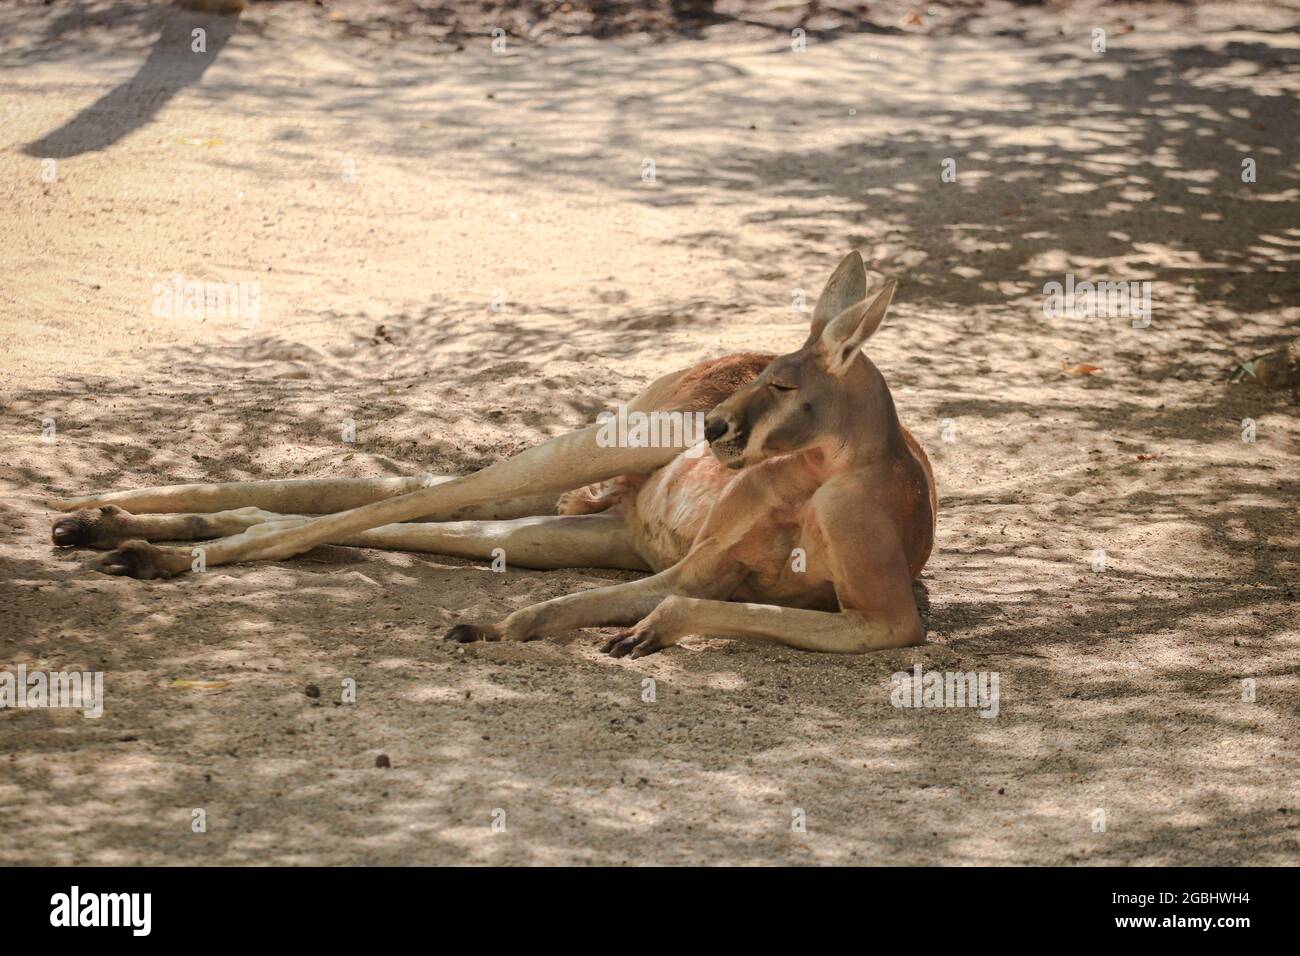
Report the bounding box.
[0,3,1300,865]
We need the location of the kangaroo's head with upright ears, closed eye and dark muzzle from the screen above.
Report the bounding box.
[705,252,894,468]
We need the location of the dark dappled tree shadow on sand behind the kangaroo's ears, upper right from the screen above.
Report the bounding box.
[431,40,1300,313]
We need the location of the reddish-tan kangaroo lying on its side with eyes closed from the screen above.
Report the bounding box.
[53,252,939,657]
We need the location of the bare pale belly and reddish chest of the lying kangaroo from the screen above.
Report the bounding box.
[628,454,835,607]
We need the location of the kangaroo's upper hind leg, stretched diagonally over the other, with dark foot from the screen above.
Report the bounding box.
[86,425,681,578]
